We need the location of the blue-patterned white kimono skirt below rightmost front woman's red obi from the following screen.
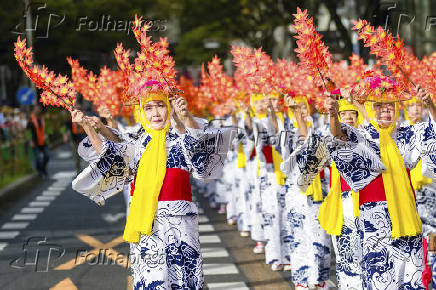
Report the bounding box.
[359,201,424,290]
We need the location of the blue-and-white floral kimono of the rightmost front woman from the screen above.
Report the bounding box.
[329,120,436,289]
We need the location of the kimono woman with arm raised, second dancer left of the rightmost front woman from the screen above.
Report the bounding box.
[281,96,331,289]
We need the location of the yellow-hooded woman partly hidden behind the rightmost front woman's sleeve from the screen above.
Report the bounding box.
[318,99,364,290]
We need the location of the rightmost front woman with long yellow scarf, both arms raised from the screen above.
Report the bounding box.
[326,85,436,289]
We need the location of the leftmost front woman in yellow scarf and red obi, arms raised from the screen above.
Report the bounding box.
[72,92,233,289]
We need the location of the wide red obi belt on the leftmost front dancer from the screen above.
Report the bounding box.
[130,168,192,201]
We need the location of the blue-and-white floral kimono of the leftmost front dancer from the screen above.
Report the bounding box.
[73,126,233,289]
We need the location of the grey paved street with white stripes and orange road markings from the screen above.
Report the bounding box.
[0,147,334,290]
